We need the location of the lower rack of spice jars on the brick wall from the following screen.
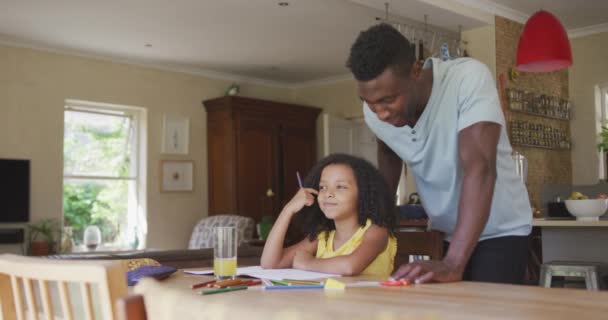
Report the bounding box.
[509,120,570,150]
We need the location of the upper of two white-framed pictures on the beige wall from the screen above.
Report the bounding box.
[161,114,190,154]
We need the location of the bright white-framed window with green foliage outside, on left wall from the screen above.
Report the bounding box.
[63,100,147,249]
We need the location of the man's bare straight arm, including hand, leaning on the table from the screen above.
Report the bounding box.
[393,122,501,283]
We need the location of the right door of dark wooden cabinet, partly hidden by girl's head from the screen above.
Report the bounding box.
[281,125,316,204]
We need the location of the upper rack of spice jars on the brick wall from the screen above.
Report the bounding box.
[505,88,572,120]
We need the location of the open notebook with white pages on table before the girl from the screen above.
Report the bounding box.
[184,266,340,280]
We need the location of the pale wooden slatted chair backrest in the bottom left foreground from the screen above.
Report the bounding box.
[0,254,127,320]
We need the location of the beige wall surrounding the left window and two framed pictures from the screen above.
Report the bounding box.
[0,46,293,252]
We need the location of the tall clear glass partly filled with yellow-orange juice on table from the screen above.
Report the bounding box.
[213,227,238,280]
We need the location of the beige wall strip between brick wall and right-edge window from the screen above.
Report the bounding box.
[569,32,608,184]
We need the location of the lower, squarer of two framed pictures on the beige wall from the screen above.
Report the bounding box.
[160,160,194,192]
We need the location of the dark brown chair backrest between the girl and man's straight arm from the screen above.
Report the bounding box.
[394,228,443,270]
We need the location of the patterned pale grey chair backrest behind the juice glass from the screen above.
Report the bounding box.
[188,214,255,249]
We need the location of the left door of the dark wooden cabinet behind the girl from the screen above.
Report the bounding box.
[237,116,279,221]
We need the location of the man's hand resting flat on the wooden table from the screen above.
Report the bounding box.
[391,260,464,283]
